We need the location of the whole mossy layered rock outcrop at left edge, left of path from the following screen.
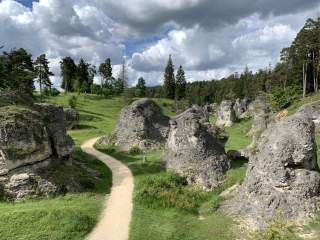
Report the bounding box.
[0,104,74,200]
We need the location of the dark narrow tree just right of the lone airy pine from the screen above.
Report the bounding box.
[60,57,77,93]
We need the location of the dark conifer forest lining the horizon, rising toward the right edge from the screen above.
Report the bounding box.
[146,18,320,108]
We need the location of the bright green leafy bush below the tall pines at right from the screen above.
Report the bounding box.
[271,86,299,110]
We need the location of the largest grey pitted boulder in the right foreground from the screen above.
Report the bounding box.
[225,113,320,228]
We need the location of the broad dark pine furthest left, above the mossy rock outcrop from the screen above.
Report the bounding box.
[5,48,35,95]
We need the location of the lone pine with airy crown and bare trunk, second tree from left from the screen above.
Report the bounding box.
[35,54,54,97]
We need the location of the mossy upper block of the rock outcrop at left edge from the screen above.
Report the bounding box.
[0,106,52,175]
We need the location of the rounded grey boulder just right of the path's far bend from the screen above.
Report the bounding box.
[101,98,169,150]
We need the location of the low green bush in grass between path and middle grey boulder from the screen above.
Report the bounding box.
[134,172,207,213]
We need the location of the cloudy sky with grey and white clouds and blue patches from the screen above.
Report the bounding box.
[0,0,320,86]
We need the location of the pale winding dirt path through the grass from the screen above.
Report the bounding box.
[81,138,133,240]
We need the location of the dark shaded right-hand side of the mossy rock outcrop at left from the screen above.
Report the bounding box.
[36,103,74,158]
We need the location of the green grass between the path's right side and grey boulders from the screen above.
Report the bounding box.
[96,146,246,240]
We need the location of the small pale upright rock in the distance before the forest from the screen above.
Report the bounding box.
[216,100,236,127]
